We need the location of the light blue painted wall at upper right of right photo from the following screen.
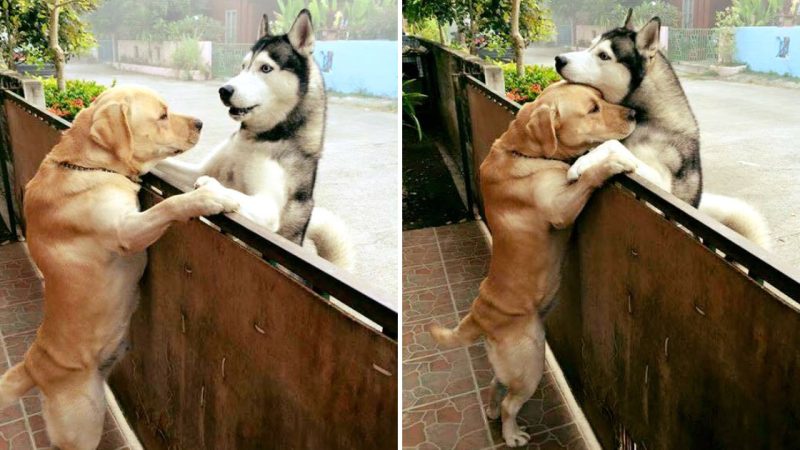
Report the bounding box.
[736,27,800,77]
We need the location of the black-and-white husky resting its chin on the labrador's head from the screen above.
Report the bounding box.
[555,10,770,249]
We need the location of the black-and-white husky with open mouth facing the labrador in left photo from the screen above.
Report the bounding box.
[159,9,353,269]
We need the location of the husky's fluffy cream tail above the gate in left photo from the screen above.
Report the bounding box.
[306,207,354,270]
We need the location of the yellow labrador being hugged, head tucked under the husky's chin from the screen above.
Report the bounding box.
[431,83,637,447]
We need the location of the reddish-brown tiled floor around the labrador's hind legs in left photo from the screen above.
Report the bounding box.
[0,243,133,450]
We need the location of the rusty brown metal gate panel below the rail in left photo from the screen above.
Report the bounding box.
[110,188,397,449]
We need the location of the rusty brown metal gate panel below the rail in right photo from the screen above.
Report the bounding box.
[547,186,800,450]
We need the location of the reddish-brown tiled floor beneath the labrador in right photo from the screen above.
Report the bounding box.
[403,222,585,450]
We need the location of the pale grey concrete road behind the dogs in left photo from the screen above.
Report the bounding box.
[66,64,400,300]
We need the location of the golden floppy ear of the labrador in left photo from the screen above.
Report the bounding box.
[89,102,133,163]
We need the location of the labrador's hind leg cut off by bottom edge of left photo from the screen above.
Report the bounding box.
[42,373,106,450]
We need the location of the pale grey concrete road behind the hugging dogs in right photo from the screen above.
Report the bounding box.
[525,47,800,269]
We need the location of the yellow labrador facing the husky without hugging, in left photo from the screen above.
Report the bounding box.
[0,87,238,450]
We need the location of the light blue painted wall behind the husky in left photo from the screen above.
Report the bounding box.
[314,41,400,98]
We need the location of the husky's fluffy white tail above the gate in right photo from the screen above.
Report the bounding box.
[698,193,772,250]
